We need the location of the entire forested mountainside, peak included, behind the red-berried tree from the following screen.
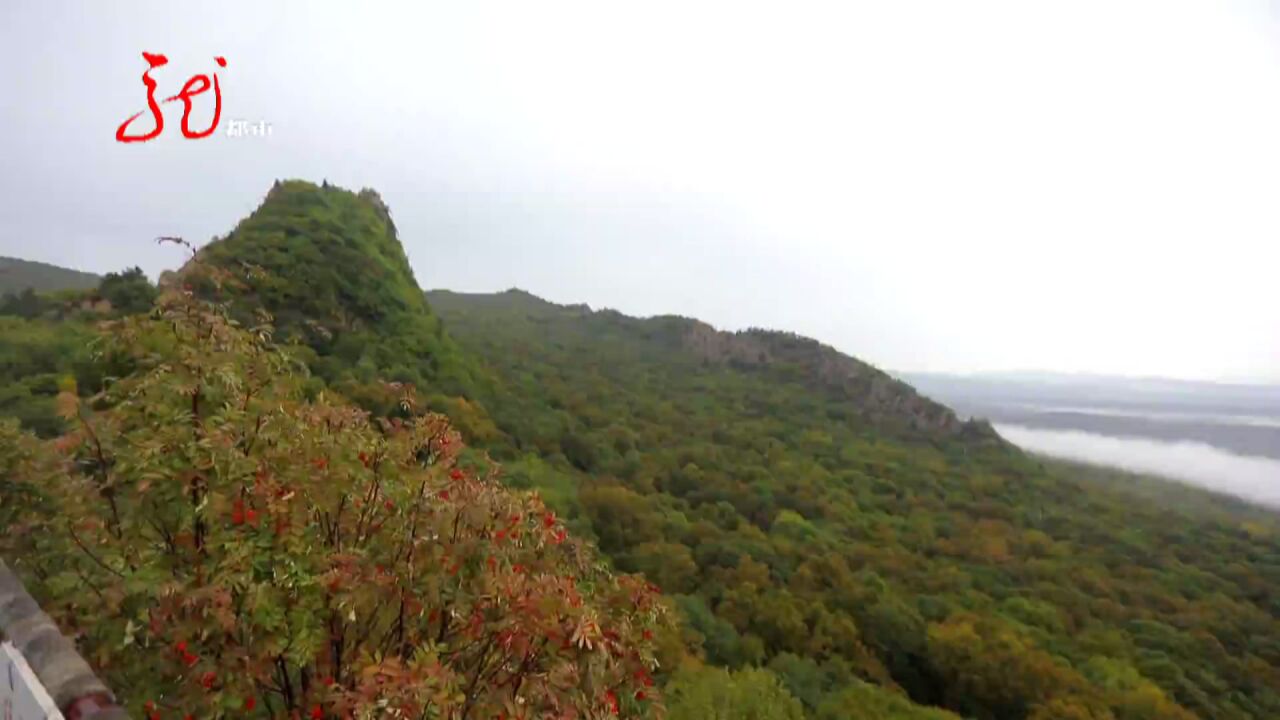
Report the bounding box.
[0,181,1280,720]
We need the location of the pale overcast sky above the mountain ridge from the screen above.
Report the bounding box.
[0,0,1280,380]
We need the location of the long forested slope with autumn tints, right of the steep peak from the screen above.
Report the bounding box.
[429,291,1280,720]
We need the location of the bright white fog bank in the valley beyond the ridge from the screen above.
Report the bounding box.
[995,423,1280,509]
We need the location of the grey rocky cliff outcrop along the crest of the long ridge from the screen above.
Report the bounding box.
[682,320,996,439]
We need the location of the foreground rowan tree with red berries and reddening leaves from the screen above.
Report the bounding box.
[0,283,668,719]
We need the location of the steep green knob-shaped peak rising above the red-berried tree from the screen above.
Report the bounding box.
[189,181,477,404]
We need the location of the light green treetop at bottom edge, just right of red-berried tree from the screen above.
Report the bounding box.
[667,667,804,720]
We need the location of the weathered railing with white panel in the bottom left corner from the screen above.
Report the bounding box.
[0,560,128,720]
